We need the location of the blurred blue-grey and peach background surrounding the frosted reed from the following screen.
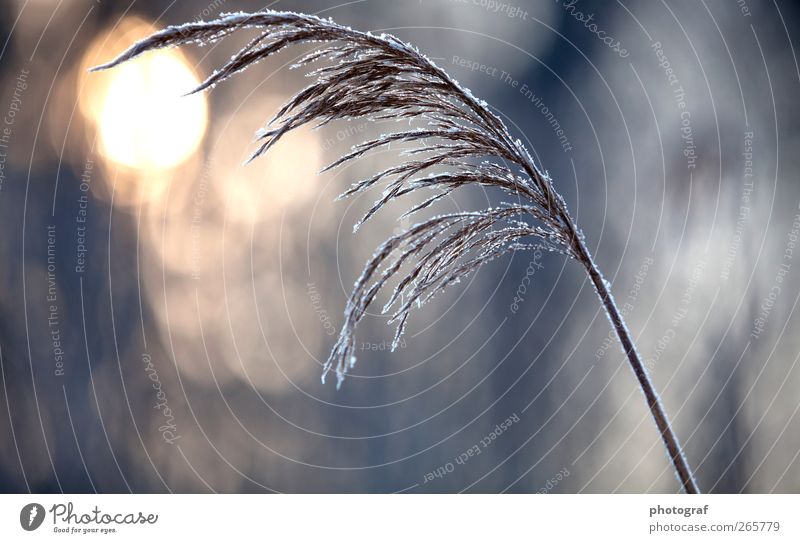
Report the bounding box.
[0,0,800,493]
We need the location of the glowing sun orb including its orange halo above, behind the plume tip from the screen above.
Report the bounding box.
[79,18,208,172]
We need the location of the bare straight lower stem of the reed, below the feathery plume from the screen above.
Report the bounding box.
[574,236,700,494]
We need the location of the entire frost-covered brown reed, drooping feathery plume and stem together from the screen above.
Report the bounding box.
[94,11,698,493]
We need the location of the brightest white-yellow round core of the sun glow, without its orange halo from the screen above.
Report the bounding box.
[97,51,207,170]
